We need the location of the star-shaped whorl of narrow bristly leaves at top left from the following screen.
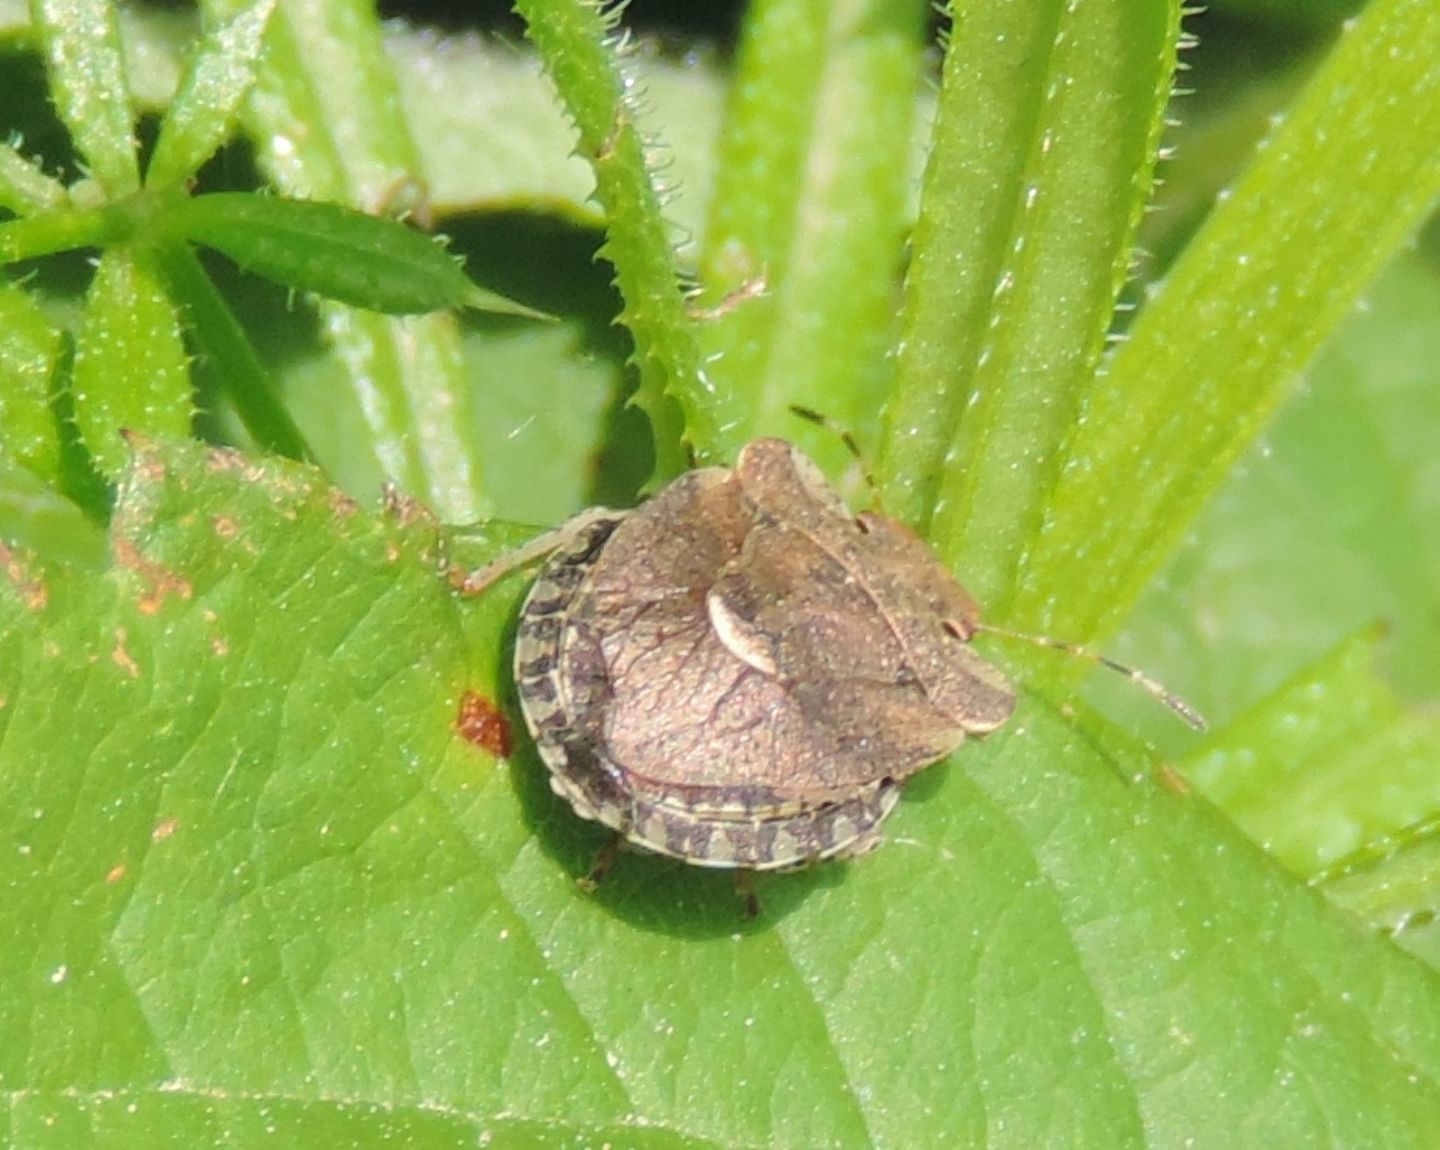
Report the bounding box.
[0,0,533,509]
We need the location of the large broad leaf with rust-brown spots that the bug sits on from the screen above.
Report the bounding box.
[0,446,1440,1150]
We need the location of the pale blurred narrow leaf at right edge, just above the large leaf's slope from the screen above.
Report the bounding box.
[1185,630,1440,875]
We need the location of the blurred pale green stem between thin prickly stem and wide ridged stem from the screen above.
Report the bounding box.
[697,0,929,471]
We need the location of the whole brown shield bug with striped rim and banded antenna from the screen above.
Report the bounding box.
[459,439,1191,871]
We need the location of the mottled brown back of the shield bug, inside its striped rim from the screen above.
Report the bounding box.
[575,440,1009,799]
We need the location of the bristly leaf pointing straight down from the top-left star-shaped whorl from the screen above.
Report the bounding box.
[72,248,194,479]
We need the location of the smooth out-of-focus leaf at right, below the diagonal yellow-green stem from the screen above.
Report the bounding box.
[1113,253,1440,748]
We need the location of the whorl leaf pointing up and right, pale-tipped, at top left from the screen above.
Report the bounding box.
[145,0,275,187]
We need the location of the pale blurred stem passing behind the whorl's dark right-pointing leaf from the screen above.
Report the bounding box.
[206,0,491,522]
